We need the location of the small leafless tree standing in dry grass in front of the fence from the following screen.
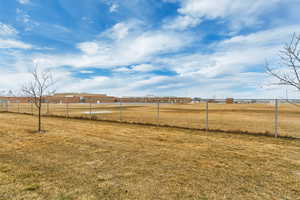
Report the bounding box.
[22,67,54,133]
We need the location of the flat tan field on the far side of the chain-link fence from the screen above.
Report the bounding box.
[3,103,300,138]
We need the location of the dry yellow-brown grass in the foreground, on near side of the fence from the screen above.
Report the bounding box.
[0,113,300,200]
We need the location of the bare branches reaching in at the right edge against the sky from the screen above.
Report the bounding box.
[266,33,300,91]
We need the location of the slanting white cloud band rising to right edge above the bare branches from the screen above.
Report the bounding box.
[158,26,300,77]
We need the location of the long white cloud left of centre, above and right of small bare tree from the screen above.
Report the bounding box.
[44,21,193,68]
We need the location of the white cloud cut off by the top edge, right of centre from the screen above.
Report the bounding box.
[165,0,294,30]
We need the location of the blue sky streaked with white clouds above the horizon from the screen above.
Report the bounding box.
[0,0,300,98]
